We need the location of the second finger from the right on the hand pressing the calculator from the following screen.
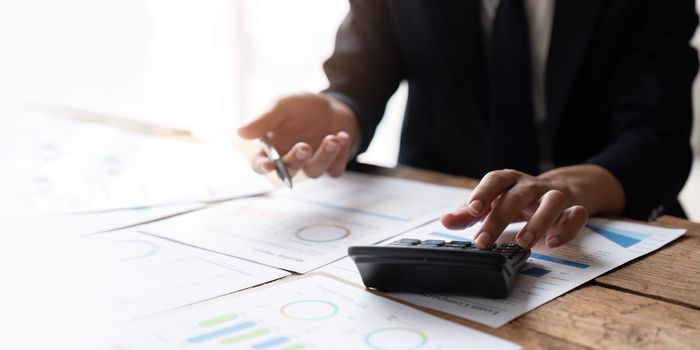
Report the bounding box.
[515,190,566,248]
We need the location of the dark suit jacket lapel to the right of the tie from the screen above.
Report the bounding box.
[546,0,602,132]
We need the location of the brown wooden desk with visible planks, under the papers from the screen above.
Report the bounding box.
[356,167,700,349]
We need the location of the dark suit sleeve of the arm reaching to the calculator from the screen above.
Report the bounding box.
[589,0,698,219]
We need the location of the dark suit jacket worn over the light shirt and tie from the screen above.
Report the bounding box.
[324,0,698,219]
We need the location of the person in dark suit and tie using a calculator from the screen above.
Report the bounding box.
[239,0,697,247]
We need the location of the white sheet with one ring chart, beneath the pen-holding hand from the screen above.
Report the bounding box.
[143,174,469,273]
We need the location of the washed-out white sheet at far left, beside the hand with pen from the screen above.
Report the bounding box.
[0,115,273,214]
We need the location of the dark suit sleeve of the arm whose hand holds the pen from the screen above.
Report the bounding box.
[323,0,401,152]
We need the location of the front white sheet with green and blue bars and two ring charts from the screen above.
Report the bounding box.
[110,275,520,350]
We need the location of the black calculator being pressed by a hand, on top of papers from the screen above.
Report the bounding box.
[348,238,530,298]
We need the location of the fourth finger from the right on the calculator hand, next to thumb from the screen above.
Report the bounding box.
[467,169,523,216]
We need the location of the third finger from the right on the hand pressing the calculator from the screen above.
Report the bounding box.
[474,182,540,248]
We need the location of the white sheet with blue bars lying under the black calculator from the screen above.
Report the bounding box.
[319,218,685,327]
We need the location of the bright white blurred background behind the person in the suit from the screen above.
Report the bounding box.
[0,0,700,221]
